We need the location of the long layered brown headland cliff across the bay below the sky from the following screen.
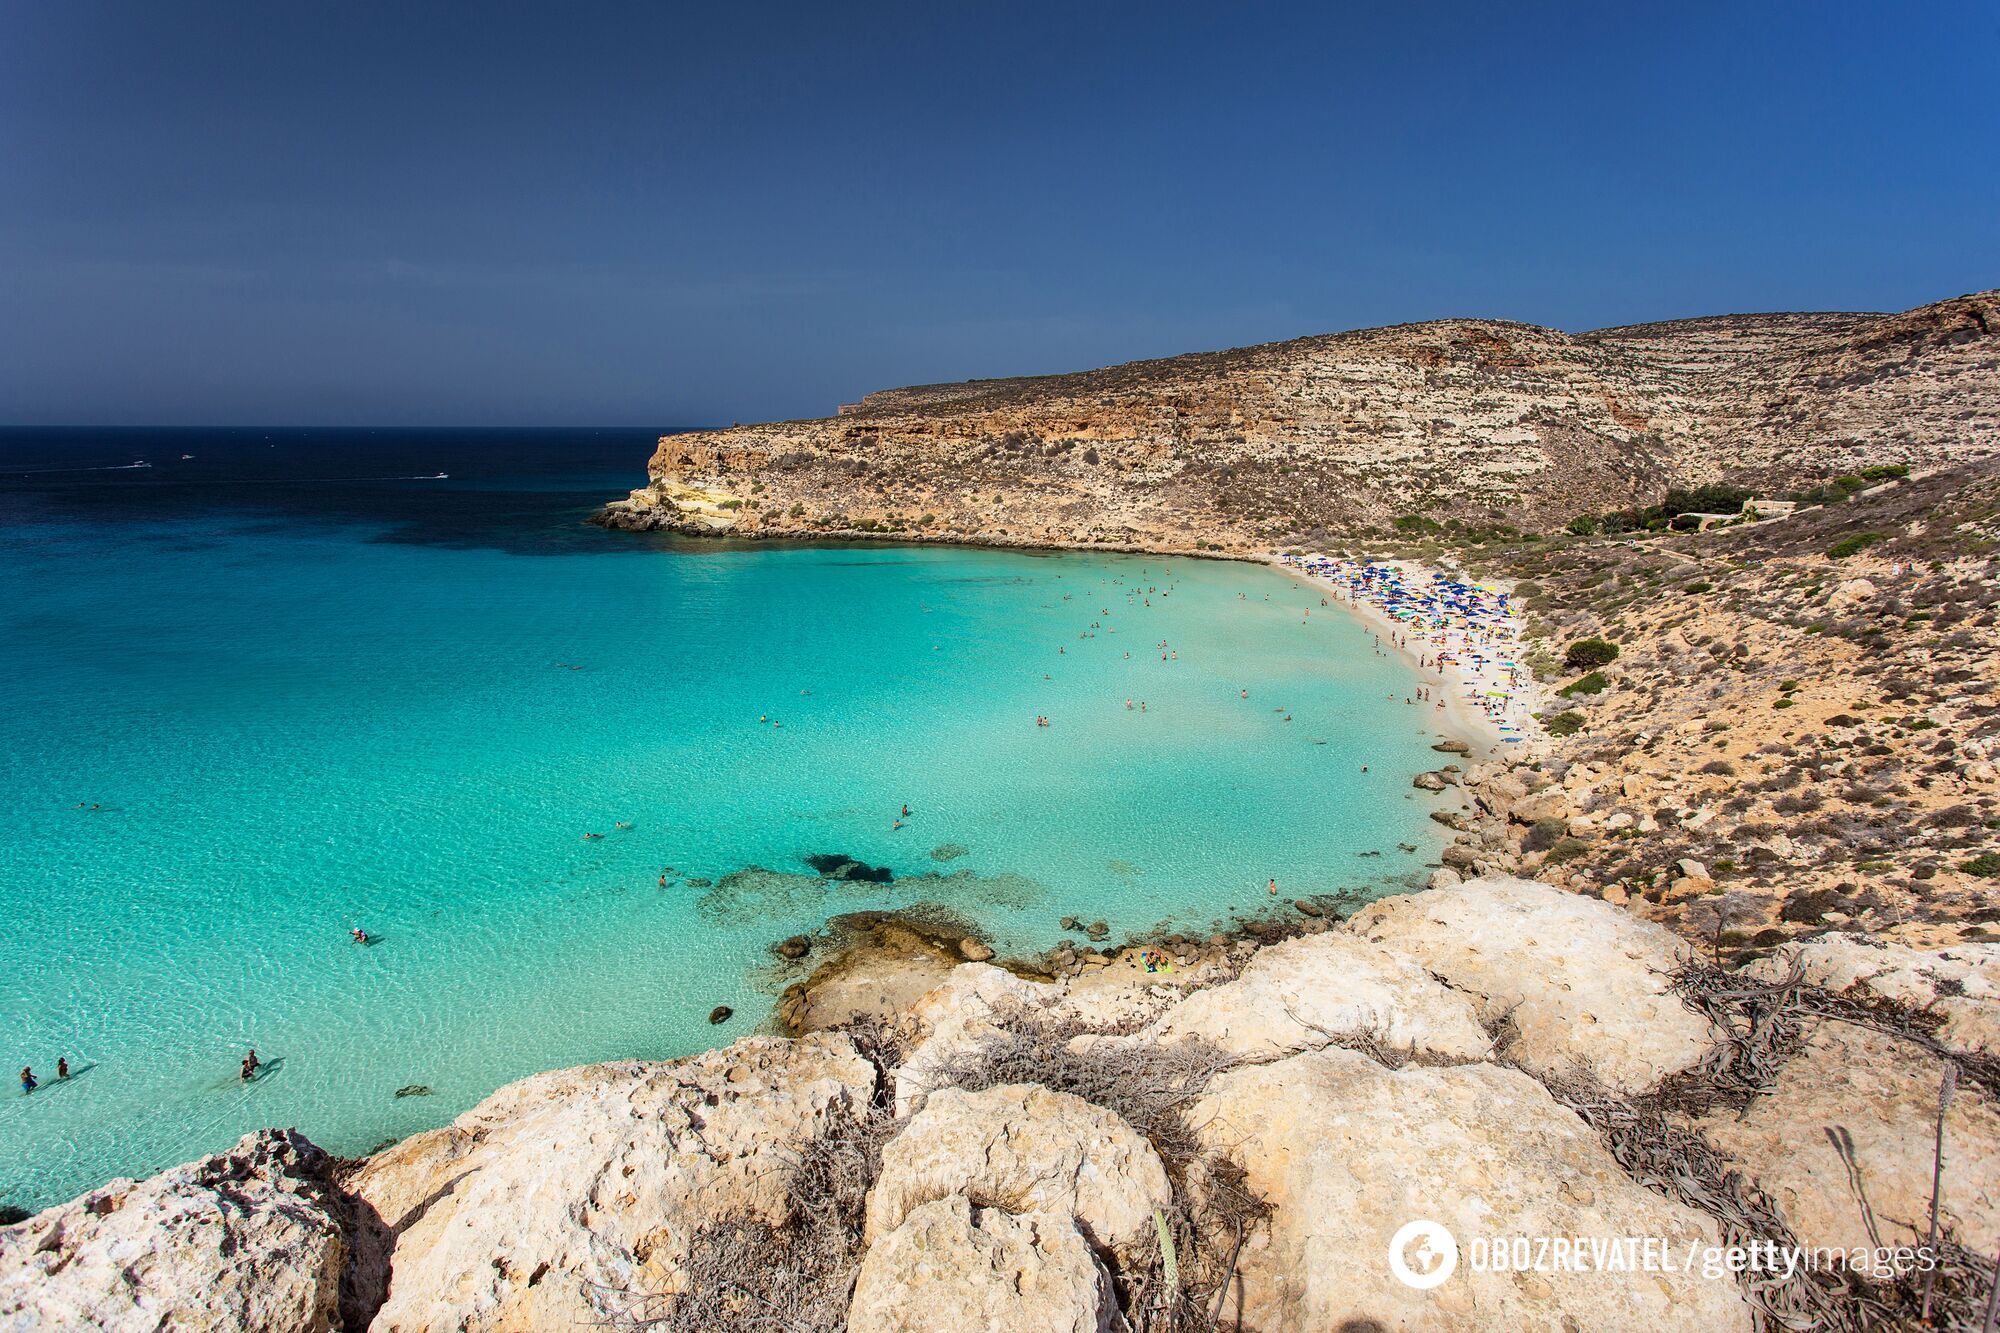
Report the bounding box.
[602,292,2000,550]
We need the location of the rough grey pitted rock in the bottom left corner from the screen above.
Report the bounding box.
[0,1129,348,1333]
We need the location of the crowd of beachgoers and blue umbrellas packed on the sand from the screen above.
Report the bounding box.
[1282,554,1534,745]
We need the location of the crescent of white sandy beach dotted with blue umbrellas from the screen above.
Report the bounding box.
[1268,554,1544,757]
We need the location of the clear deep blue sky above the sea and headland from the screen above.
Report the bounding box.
[0,0,2000,426]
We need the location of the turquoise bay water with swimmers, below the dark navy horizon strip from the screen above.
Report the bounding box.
[0,430,1436,1207]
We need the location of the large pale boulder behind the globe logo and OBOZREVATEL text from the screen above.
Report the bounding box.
[1196,1049,1750,1333]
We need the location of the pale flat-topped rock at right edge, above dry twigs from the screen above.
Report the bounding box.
[1758,935,2000,1055]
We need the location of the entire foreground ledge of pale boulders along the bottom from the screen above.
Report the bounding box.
[0,879,2000,1333]
